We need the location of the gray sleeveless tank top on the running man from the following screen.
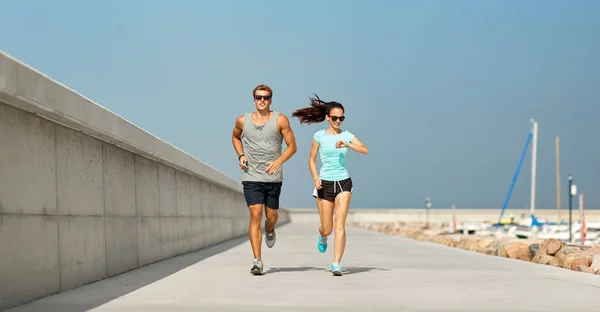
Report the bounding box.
[242,112,283,182]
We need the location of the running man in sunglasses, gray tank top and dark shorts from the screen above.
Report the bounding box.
[231,85,296,275]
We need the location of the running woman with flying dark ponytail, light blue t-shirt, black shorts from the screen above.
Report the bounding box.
[292,95,369,276]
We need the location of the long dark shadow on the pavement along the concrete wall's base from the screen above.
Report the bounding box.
[3,235,248,312]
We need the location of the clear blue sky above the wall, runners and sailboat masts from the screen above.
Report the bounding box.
[0,0,600,209]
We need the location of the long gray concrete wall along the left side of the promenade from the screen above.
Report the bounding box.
[0,51,289,309]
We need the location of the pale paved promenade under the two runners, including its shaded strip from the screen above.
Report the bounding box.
[9,223,600,312]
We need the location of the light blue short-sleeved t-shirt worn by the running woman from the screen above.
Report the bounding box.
[313,130,354,181]
